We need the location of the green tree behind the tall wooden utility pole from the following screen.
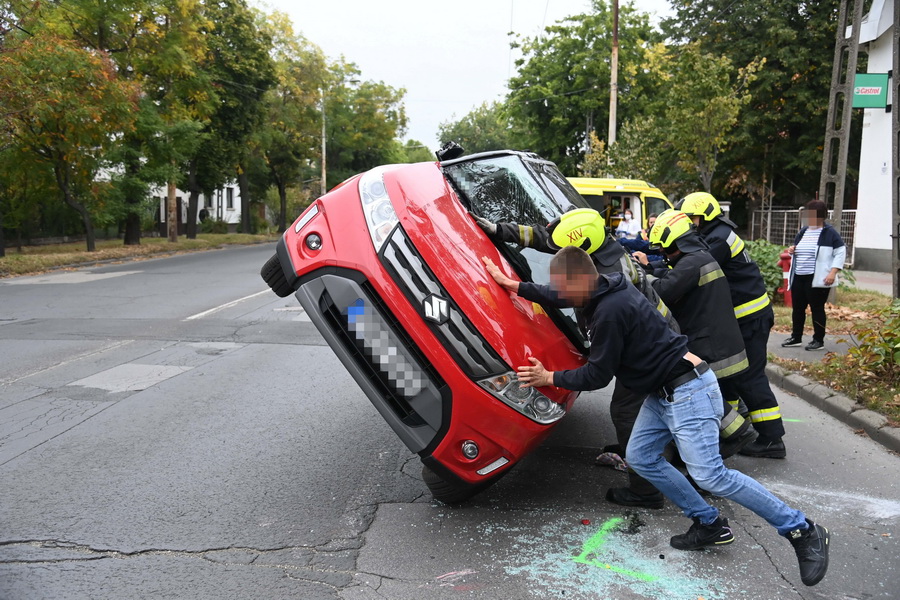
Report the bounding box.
[507,0,662,173]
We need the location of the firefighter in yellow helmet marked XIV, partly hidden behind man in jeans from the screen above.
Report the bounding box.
[475,208,753,508]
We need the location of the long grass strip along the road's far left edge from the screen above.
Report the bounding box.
[0,233,279,277]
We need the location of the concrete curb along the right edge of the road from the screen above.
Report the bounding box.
[766,364,900,453]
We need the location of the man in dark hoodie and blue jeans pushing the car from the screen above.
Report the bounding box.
[483,246,829,585]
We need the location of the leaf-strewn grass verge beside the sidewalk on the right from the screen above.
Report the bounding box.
[770,287,900,427]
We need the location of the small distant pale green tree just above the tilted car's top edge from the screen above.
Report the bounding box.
[438,102,526,153]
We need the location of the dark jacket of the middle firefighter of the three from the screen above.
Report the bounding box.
[652,245,749,379]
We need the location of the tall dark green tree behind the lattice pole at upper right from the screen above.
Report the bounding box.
[663,0,839,209]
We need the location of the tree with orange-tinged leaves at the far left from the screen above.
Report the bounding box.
[0,34,138,251]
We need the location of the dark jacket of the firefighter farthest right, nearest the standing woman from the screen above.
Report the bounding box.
[700,216,772,321]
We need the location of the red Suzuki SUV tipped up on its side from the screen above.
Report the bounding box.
[261,150,587,503]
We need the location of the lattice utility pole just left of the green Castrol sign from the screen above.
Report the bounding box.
[819,0,864,232]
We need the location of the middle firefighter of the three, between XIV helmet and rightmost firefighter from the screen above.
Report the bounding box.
[633,209,755,458]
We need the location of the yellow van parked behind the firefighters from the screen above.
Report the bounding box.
[566,177,672,229]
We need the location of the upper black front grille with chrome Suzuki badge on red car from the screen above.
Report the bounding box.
[381,226,509,379]
